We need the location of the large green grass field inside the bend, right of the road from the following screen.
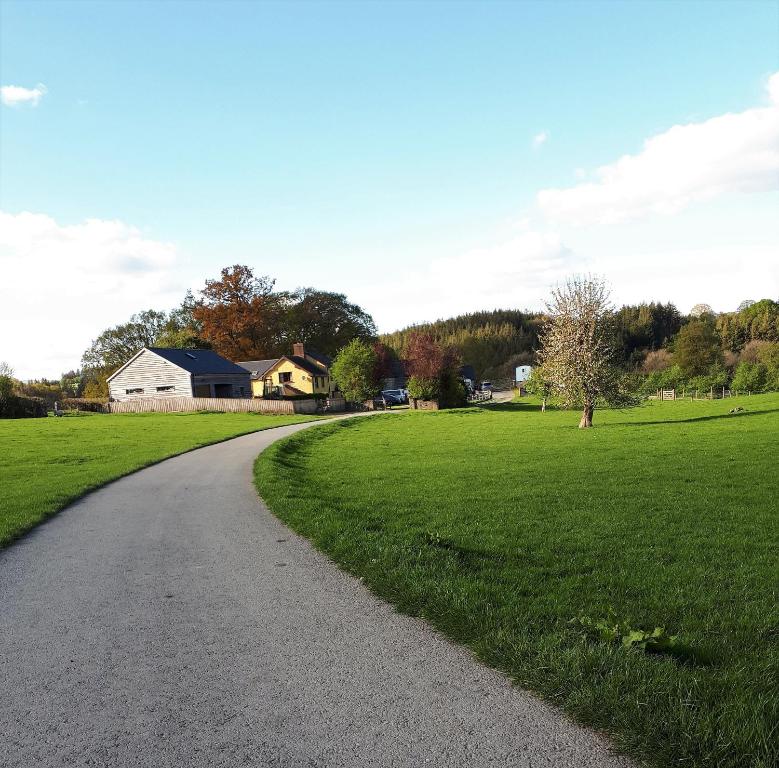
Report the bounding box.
[256,395,779,768]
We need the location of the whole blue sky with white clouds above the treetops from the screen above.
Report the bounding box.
[0,0,779,379]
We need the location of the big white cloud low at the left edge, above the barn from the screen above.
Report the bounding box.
[0,211,185,378]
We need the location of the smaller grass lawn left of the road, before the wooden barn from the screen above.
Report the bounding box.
[0,413,320,547]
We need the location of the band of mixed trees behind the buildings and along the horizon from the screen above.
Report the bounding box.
[6,265,779,412]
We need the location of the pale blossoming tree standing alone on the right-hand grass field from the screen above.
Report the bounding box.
[539,277,627,428]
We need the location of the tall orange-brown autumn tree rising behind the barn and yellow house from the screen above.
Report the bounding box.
[192,264,289,360]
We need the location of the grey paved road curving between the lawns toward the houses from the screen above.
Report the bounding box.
[0,426,629,768]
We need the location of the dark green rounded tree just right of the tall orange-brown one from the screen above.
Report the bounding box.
[283,288,376,356]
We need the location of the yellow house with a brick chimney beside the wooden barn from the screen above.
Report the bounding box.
[238,343,333,397]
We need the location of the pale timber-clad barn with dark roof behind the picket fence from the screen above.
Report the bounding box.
[107,347,252,402]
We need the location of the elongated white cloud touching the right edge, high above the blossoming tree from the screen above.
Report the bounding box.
[537,72,779,226]
